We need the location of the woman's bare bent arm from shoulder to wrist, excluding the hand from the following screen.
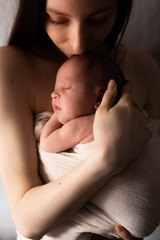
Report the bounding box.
[0,59,112,239]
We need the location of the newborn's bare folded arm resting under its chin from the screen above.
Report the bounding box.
[40,114,94,152]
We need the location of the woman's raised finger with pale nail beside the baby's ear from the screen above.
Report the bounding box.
[100,80,117,111]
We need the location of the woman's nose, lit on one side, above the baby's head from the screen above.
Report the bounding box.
[70,23,87,55]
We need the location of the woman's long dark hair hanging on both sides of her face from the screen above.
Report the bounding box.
[8,0,133,54]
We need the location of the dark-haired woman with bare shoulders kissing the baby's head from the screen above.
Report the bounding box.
[0,0,160,240]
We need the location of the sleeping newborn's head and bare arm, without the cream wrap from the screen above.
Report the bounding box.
[40,53,126,152]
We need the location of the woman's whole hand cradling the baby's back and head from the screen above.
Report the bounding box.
[93,80,151,174]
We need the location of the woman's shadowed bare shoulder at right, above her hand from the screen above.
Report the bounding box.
[121,44,160,118]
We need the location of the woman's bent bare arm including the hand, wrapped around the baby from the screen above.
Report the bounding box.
[0,48,149,239]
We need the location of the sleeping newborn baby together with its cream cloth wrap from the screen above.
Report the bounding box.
[35,54,160,240]
